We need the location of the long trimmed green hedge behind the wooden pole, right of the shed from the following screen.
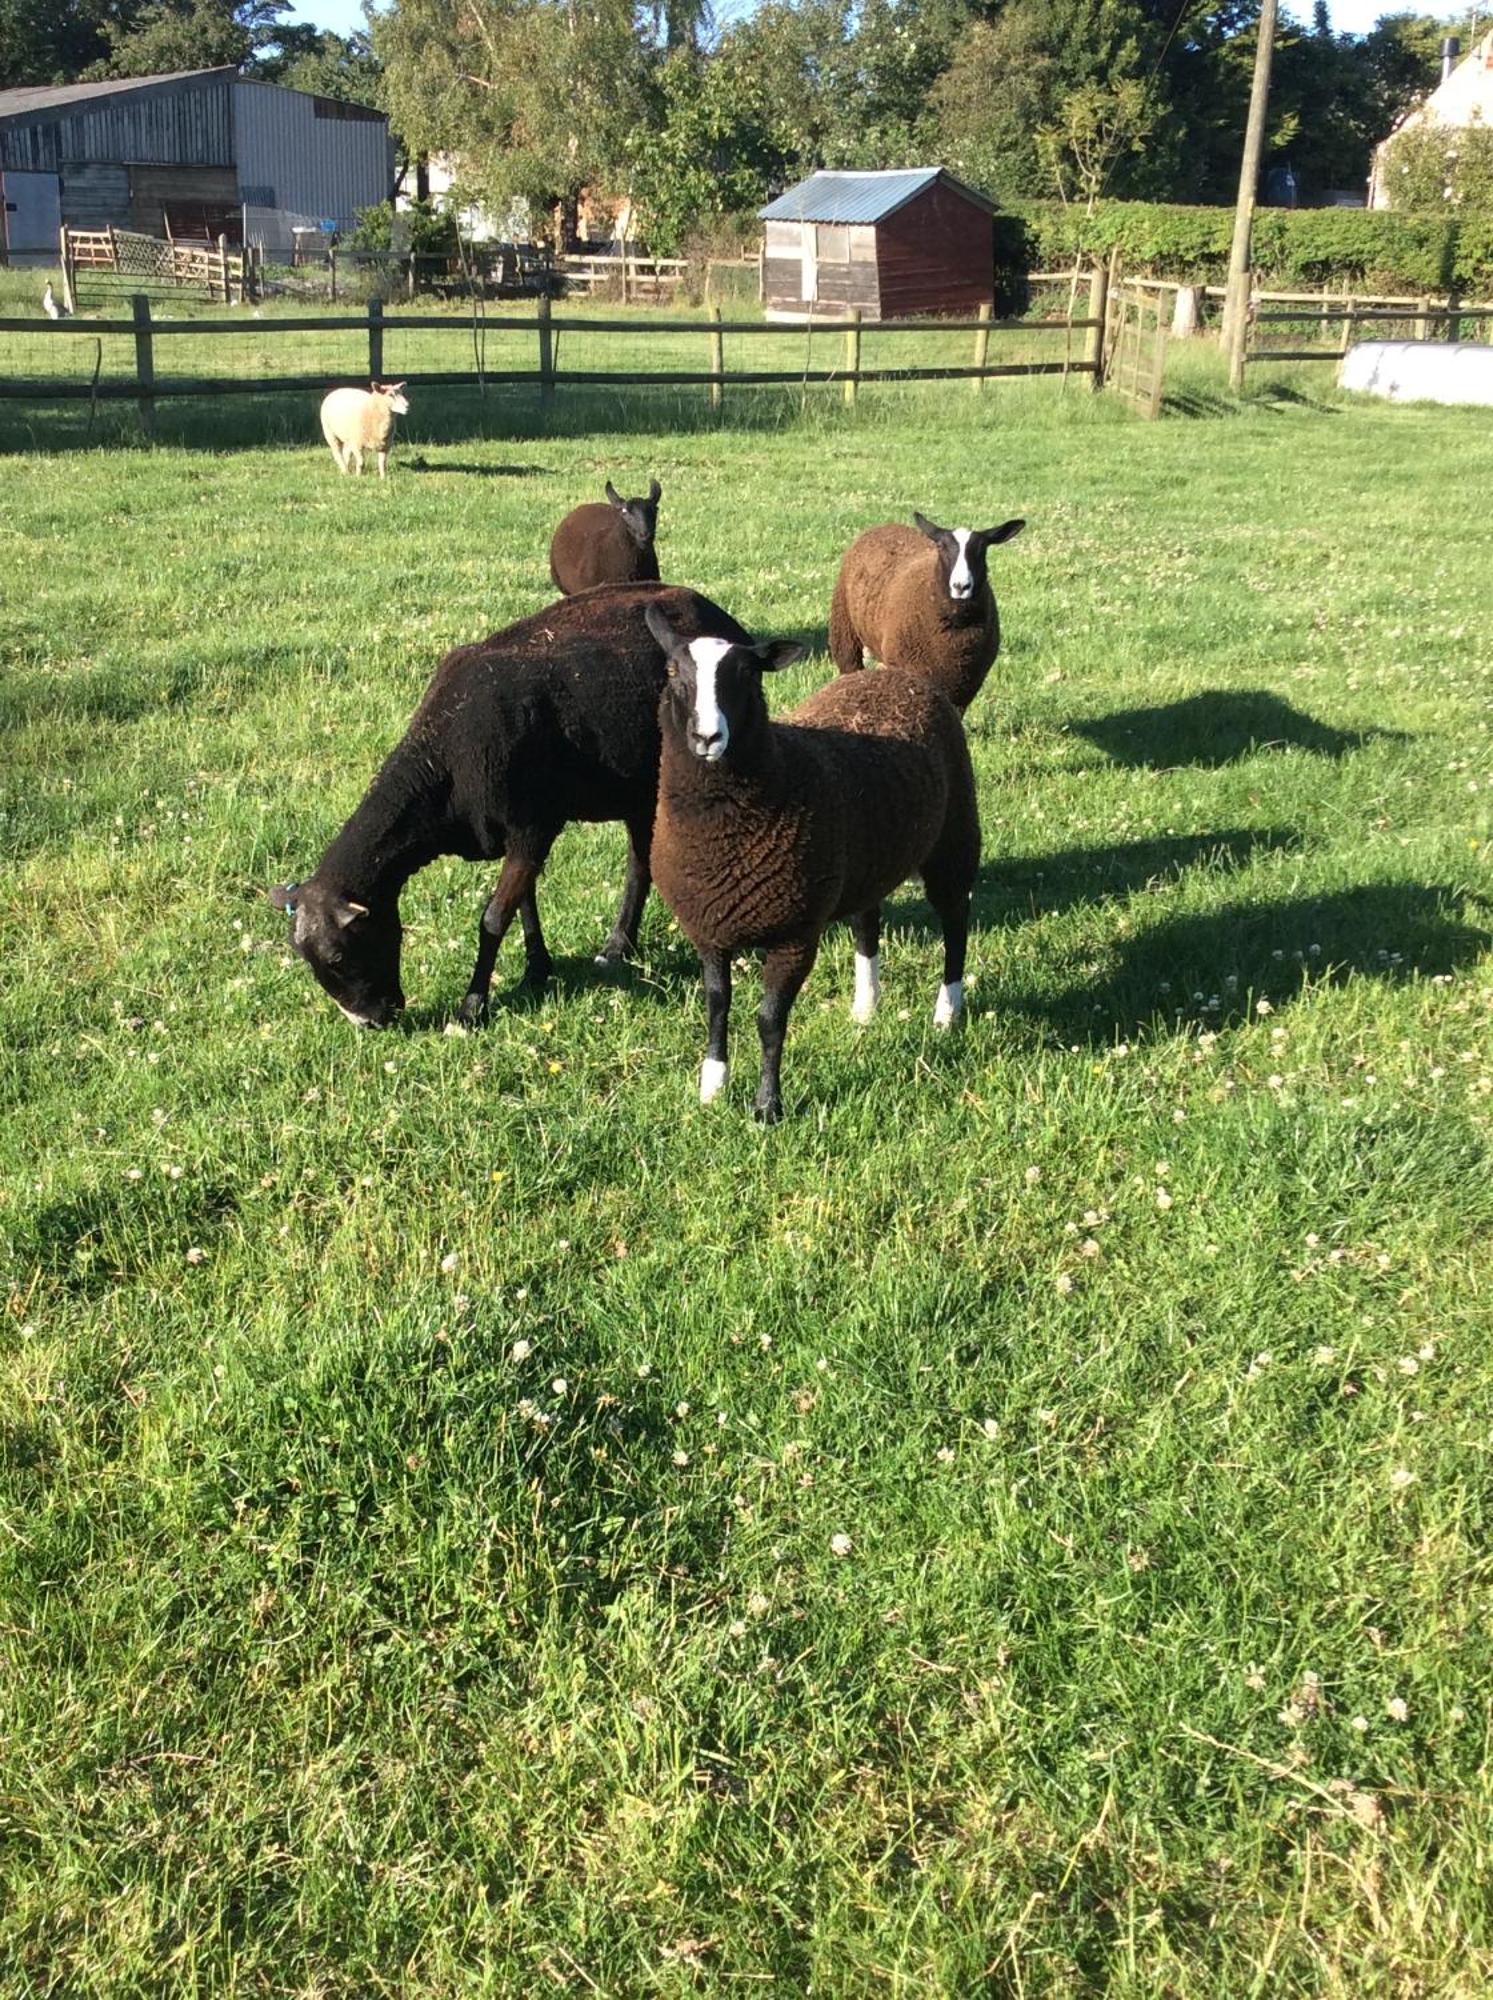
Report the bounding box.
[995,202,1493,296]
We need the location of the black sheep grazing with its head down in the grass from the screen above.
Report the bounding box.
[270,584,751,1028]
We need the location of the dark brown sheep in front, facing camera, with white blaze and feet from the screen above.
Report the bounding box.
[648,606,981,1124]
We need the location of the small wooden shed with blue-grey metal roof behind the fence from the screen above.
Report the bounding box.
[759,166,995,320]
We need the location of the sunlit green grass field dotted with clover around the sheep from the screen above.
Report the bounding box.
[0,366,1493,2000]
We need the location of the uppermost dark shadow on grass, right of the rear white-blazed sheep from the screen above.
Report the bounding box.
[1069,688,1403,770]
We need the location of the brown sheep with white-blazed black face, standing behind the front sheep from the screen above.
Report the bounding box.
[829,514,1027,716]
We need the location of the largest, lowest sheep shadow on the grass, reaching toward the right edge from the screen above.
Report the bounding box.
[993,882,1493,1046]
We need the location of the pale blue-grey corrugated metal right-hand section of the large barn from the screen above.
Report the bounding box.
[234,82,394,258]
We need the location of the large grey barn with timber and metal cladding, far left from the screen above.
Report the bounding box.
[0,68,394,262]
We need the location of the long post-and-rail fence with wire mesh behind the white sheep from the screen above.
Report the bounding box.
[0,294,1095,450]
